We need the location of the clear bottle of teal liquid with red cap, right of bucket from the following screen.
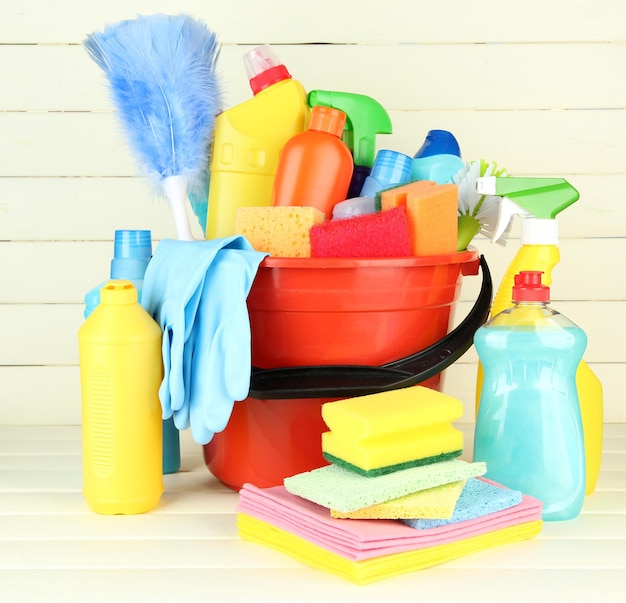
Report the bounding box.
[474,271,587,521]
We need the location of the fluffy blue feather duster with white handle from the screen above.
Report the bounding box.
[84,14,220,240]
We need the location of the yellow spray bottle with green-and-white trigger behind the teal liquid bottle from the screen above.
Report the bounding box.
[476,176,604,494]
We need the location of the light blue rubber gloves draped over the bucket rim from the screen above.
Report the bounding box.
[142,236,267,444]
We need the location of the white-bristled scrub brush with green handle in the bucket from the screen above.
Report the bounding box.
[452,159,510,251]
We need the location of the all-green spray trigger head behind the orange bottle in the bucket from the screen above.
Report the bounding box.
[307,90,392,167]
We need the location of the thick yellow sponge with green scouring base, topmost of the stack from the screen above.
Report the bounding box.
[322,385,463,475]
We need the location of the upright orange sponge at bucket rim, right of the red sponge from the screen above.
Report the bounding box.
[406,184,459,255]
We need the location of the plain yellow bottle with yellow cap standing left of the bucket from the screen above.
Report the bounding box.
[78,280,163,515]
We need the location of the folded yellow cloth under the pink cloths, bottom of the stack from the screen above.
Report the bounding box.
[237,513,542,584]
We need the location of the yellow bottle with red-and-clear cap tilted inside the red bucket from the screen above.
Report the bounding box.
[206,44,309,239]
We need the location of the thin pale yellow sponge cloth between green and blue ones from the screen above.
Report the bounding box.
[330,480,466,519]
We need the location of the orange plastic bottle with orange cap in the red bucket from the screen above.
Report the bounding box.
[272,105,354,220]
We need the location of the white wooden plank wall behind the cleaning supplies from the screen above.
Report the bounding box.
[0,0,626,424]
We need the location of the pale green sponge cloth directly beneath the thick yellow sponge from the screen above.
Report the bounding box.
[284,459,487,513]
